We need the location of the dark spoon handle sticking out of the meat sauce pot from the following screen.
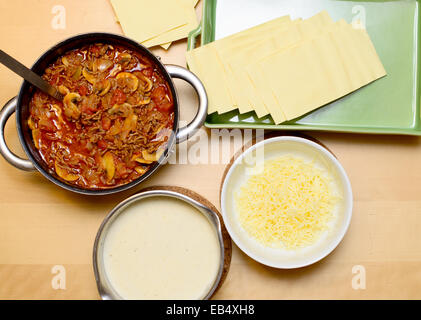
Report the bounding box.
[0,49,63,101]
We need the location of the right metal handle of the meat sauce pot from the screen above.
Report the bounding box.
[165,64,208,143]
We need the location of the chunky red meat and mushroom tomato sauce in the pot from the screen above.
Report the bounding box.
[28,44,174,189]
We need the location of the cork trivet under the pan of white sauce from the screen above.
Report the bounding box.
[138,186,232,298]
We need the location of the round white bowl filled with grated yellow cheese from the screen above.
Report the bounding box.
[221,136,353,269]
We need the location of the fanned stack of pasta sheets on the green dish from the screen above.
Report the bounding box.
[186,11,386,124]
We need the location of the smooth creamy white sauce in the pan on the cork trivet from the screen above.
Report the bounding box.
[103,197,221,299]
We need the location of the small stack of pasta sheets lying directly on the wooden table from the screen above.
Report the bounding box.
[110,0,198,49]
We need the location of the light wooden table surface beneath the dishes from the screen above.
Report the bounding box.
[0,0,421,299]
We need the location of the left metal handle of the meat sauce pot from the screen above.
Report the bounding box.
[0,97,35,171]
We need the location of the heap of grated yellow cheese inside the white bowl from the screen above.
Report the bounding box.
[235,155,340,250]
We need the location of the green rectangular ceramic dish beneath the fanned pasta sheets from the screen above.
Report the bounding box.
[189,0,421,135]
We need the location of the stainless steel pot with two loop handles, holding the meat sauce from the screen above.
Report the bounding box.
[0,33,208,195]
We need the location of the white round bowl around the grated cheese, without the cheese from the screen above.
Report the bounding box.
[221,136,353,269]
